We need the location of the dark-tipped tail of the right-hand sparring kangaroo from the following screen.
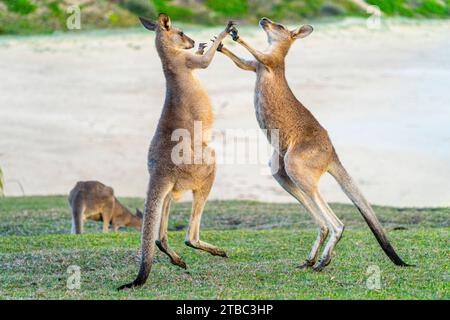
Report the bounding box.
[328,157,410,267]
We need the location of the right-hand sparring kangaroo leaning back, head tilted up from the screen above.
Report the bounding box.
[218,18,407,271]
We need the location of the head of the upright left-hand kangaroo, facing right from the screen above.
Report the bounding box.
[139,13,195,49]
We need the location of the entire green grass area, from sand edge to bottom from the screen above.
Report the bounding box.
[0,196,450,299]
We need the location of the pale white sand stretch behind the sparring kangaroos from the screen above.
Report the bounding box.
[0,21,450,206]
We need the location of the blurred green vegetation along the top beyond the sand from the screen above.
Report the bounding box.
[0,0,450,34]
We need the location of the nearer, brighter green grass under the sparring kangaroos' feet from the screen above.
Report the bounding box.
[0,229,450,299]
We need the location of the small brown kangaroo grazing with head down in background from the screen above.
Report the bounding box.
[69,181,142,234]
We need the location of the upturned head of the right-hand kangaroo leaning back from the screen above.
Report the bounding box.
[259,17,313,53]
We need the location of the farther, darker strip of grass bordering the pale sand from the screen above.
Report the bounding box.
[0,196,450,236]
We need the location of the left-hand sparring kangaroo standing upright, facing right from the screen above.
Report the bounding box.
[119,14,233,290]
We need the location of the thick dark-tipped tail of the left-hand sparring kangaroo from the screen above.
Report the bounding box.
[118,182,165,290]
